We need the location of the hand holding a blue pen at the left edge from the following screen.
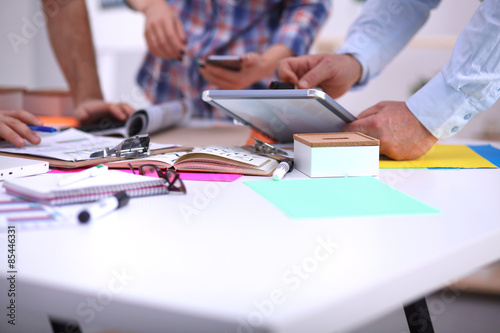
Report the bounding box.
[0,110,43,147]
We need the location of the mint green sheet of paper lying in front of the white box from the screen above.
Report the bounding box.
[245,177,440,218]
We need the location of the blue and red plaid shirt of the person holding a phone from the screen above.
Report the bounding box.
[137,0,330,118]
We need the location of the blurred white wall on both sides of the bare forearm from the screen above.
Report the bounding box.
[0,0,145,100]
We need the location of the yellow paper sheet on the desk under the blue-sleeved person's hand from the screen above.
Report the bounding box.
[379,145,497,169]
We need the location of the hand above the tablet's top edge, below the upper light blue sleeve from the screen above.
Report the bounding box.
[278,54,361,98]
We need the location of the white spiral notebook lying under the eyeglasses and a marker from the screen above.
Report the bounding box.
[3,170,168,205]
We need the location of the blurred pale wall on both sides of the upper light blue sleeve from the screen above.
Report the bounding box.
[315,0,479,107]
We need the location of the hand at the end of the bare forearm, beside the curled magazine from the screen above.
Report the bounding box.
[75,99,135,125]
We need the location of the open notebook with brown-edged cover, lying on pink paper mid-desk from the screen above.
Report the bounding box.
[107,146,278,176]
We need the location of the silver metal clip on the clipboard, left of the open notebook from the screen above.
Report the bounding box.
[90,134,149,158]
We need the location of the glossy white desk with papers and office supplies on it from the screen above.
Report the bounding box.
[0,130,500,333]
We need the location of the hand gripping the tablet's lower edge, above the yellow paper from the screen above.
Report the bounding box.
[342,101,437,160]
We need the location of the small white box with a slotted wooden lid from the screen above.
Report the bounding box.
[293,132,380,177]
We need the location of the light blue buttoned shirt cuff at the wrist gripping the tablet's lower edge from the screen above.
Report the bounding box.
[406,72,479,139]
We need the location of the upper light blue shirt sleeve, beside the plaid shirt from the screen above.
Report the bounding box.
[337,0,441,86]
